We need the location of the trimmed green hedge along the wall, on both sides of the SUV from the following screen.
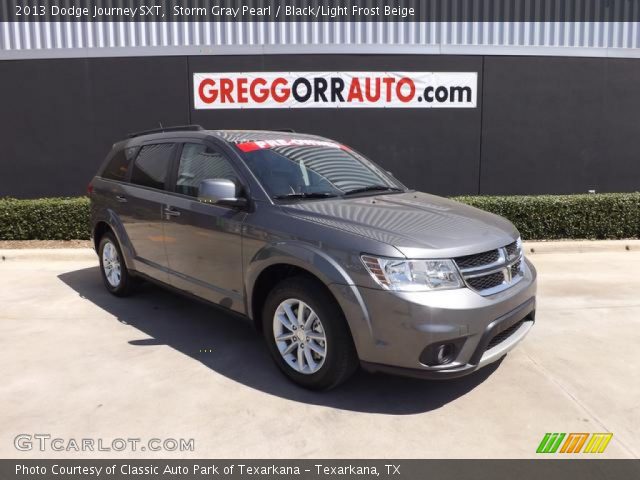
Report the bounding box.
[0,193,640,240]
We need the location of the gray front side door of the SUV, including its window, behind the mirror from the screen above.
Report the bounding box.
[165,141,246,312]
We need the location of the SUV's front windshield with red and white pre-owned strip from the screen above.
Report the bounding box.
[237,139,405,199]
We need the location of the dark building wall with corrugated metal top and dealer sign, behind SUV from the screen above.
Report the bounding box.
[0,0,640,198]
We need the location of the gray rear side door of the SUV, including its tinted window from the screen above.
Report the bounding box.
[118,142,177,283]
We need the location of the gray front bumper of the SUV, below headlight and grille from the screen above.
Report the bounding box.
[332,261,536,379]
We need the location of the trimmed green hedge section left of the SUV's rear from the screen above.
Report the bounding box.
[0,197,89,240]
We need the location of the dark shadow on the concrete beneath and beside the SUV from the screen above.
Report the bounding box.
[58,267,501,415]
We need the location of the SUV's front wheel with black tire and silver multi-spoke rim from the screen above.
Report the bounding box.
[262,277,359,390]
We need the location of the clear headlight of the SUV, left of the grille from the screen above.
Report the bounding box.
[361,255,463,292]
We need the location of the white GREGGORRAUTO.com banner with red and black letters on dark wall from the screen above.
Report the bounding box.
[193,72,478,110]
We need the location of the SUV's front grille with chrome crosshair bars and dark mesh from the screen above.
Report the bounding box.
[453,240,524,296]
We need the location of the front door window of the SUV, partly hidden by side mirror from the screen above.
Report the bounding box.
[176,143,236,197]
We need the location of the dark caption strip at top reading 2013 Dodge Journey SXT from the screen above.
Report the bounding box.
[0,0,640,22]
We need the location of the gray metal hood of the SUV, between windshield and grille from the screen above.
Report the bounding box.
[282,192,518,258]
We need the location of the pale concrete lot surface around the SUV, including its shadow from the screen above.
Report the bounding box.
[0,243,640,458]
